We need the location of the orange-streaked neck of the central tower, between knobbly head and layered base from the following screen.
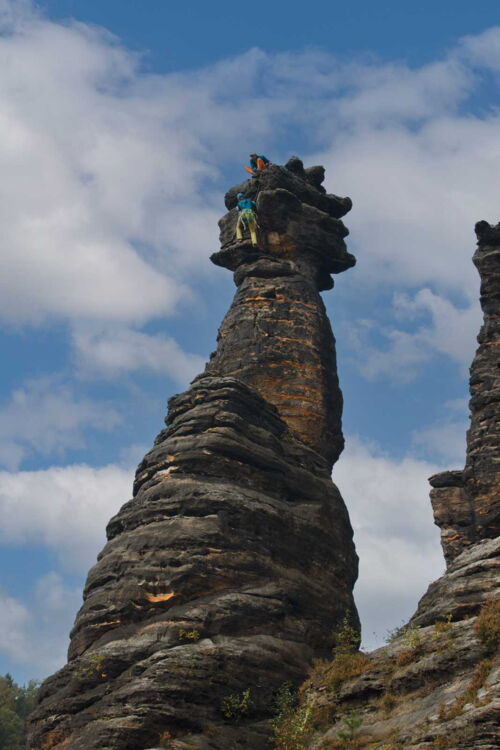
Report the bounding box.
[206,257,344,465]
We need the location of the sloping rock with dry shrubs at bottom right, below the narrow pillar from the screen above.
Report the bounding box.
[292,538,500,750]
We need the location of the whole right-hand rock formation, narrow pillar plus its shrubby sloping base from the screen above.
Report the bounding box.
[282,222,500,750]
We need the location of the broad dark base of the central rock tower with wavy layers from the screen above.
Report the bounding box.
[29,377,359,750]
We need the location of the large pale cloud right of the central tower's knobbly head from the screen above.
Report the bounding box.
[318,115,500,301]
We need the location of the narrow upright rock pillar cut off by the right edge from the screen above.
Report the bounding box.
[429,221,500,562]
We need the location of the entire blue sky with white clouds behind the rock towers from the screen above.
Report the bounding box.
[0,0,500,681]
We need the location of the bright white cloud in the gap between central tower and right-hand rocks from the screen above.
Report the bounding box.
[333,437,444,648]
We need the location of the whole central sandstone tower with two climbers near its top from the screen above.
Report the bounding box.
[29,158,358,750]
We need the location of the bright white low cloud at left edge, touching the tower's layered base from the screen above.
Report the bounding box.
[0,465,133,573]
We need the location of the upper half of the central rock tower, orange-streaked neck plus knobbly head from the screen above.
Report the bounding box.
[205,159,355,466]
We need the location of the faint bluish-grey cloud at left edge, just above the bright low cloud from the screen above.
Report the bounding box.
[0,376,121,469]
